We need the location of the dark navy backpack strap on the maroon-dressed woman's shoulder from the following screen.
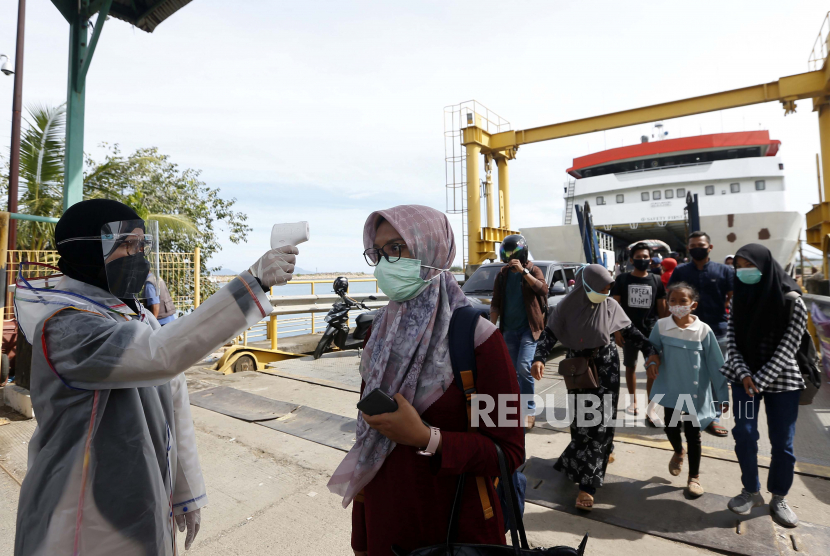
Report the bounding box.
[449,306,495,520]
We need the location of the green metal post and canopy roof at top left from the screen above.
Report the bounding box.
[52,0,191,210]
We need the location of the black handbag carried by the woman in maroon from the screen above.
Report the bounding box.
[392,442,588,556]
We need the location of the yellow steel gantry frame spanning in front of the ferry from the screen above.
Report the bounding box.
[460,12,830,278]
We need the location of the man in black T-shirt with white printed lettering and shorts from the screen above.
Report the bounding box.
[611,243,668,422]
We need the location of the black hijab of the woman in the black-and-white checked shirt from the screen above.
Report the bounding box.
[731,243,801,371]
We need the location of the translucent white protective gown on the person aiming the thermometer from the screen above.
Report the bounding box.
[14,272,270,556]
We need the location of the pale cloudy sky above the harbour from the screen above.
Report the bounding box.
[0,0,827,271]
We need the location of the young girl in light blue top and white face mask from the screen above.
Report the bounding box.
[646,282,729,498]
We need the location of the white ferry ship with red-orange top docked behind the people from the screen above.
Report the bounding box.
[521,129,802,266]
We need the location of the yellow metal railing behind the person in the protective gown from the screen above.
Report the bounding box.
[3,247,202,319]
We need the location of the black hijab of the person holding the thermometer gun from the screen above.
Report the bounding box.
[55,199,141,313]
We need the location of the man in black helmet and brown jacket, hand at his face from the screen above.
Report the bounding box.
[490,234,548,428]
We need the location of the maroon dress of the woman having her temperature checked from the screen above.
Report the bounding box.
[352,319,524,556]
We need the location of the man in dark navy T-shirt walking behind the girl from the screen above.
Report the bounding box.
[669,231,735,437]
